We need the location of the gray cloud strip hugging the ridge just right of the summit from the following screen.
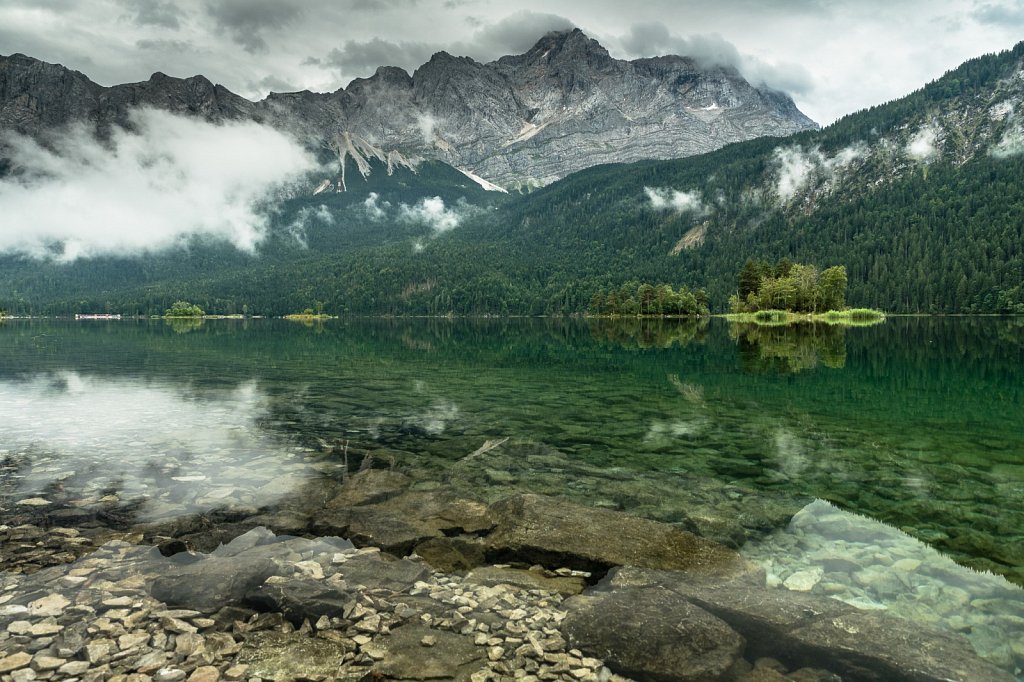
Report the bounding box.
[620,22,814,94]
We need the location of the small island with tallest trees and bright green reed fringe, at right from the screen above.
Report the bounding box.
[724,258,886,327]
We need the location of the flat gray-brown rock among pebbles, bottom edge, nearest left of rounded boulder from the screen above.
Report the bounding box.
[371,625,485,682]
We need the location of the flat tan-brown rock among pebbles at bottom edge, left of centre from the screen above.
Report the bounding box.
[236,631,346,680]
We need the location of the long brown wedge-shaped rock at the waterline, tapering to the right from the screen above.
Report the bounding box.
[487,495,758,576]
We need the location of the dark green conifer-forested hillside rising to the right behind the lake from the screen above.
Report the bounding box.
[0,43,1024,314]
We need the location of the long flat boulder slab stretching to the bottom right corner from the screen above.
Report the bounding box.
[602,567,1014,682]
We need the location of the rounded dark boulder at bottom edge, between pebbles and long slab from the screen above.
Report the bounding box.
[561,587,743,682]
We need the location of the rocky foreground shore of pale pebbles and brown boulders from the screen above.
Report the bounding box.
[0,470,1014,682]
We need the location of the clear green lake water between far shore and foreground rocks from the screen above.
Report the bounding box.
[0,317,1024,584]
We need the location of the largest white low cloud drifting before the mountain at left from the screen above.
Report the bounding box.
[0,110,315,261]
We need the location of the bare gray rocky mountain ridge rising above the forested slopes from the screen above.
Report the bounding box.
[0,30,815,186]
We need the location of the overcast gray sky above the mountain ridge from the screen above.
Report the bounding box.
[0,0,1024,124]
